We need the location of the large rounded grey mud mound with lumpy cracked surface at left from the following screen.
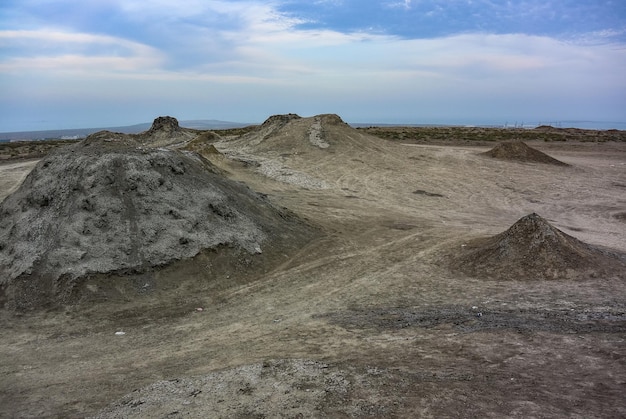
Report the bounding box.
[0,138,313,308]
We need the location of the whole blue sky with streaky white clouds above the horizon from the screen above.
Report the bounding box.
[0,0,626,132]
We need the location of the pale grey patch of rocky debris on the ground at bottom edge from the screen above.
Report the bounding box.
[94,360,350,419]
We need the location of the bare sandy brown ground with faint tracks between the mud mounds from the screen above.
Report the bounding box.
[0,125,626,418]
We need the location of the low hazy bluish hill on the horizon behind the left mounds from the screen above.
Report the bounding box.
[0,119,251,142]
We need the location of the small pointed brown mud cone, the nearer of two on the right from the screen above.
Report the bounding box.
[452,213,626,280]
